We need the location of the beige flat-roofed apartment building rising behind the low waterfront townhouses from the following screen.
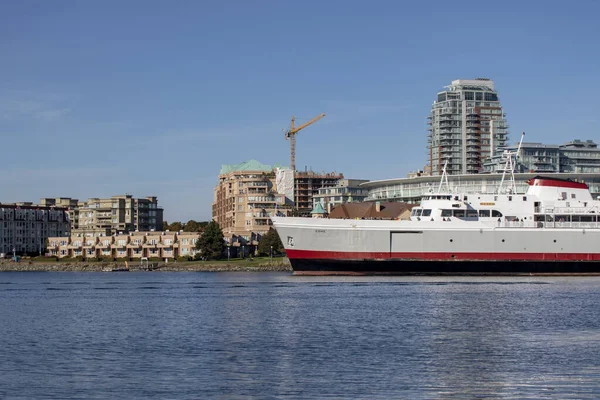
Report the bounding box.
[40,194,163,234]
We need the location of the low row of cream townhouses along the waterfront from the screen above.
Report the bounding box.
[47,231,200,261]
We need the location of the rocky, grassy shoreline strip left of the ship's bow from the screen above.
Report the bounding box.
[0,259,292,272]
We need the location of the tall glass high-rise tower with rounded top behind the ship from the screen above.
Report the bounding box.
[428,78,508,175]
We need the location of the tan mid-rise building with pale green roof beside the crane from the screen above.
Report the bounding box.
[212,160,291,247]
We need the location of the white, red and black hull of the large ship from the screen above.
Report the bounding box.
[272,217,600,274]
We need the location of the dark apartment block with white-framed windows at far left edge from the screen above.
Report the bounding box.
[0,202,71,255]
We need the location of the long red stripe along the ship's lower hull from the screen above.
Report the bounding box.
[286,249,600,261]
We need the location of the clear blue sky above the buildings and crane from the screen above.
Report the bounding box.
[0,0,600,221]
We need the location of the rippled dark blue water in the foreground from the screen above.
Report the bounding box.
[0,272,600,399]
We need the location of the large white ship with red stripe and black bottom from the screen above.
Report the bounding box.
[272,141,600,275]
